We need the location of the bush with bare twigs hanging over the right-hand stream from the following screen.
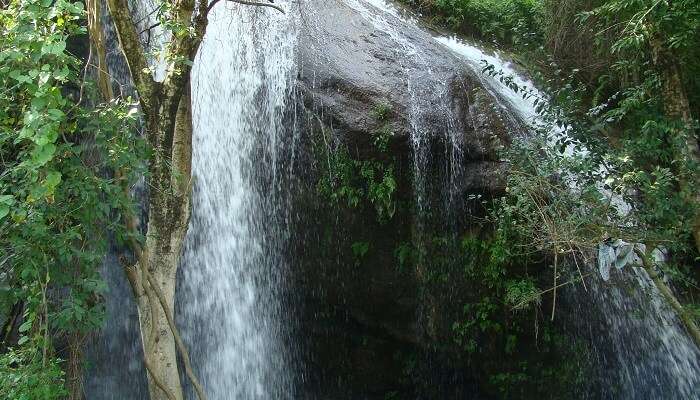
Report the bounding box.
[484,66,696,253]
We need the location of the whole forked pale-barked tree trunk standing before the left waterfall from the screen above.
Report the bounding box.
[101,0,212,400]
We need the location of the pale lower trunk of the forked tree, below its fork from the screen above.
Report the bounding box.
[137,90,197,400]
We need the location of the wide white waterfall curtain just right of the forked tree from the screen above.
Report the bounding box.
[178,2,296,400]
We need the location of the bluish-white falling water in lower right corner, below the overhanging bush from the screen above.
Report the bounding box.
[567,267,700,400]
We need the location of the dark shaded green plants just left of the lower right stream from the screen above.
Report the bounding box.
[438,234,588,399]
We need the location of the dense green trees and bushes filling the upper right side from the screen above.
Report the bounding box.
[400,0,700,318]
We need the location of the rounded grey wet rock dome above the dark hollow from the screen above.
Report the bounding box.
[299,0,510,183]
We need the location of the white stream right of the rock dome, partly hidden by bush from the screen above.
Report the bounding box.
[436,14,700,399]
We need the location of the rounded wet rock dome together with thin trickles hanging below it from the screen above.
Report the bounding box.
[300,0,513,225]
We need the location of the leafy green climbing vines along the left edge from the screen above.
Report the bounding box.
[0,0,145,390]
